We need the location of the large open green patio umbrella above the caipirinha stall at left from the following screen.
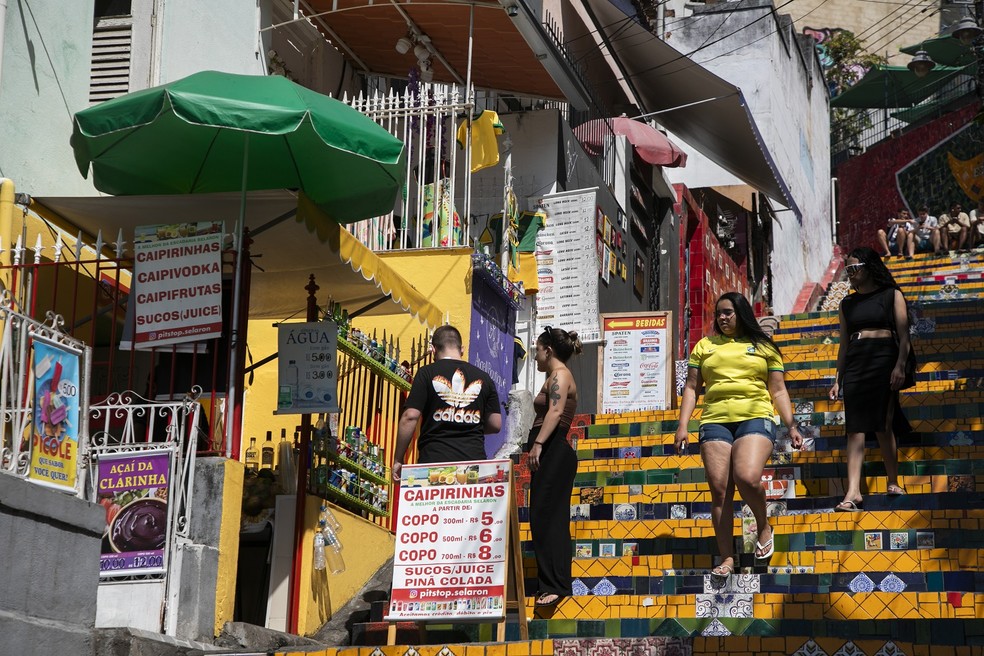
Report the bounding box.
[71,71,406,223]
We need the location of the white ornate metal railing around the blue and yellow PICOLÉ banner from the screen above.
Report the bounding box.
[0,289,91,491]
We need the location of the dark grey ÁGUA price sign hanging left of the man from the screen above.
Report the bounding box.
[276,321,338,415]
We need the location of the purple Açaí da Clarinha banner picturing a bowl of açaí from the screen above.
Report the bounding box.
[98,451,171,578]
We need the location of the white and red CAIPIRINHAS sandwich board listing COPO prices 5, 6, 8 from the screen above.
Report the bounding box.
[386,460,512,621]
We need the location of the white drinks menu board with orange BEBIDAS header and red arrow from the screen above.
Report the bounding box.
[598,312,673,414]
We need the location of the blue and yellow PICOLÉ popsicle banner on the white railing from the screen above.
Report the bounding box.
[28,337,82,492]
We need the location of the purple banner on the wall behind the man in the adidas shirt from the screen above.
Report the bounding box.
[468,276,516,458]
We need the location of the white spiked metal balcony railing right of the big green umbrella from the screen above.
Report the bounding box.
[342,83,474,251]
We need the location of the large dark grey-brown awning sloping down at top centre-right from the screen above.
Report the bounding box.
[584,0,800,214]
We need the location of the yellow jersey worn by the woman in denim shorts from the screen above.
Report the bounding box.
[687,335,783,424]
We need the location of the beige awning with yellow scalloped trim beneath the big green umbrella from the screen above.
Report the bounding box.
[32,191,444,328]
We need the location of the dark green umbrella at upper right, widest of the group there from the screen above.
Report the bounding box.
[830,66,976,109]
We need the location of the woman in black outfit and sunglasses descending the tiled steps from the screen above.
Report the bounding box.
[830,248,909,512]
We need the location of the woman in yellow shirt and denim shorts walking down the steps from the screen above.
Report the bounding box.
[676,292,803,578]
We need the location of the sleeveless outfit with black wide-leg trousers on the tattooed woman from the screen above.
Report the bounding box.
[526,392,577,597]
